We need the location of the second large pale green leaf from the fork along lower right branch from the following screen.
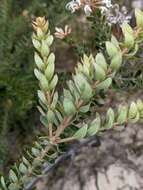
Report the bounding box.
[88,113,101,136]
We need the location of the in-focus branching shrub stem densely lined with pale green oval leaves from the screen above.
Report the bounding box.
[1,5,143,190]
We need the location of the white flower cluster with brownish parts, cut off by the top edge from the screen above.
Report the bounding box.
[66,0,112,16]
